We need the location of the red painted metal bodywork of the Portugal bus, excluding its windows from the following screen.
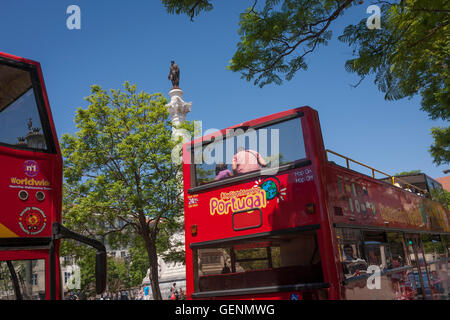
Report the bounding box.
[183,107,450,299]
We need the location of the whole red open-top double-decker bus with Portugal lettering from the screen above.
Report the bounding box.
[183,107,450,300]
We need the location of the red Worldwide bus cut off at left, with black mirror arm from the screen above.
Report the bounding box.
[0,52,106,300]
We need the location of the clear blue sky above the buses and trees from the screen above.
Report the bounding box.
[0,0,448,178]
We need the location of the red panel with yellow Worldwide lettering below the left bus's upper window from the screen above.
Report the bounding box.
[0,147,61,238]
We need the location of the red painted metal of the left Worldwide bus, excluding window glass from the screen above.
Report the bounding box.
[0,52,62,298]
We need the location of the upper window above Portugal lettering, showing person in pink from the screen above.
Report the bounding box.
[193,117,306,186]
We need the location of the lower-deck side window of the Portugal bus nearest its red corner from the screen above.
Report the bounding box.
[336,228,367,278]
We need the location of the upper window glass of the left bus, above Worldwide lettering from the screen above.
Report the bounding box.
[0,64,48,151]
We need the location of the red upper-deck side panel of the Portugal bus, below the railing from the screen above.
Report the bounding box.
[328,164,450,232]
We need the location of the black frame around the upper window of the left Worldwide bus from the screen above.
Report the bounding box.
[0,57,56,154]
